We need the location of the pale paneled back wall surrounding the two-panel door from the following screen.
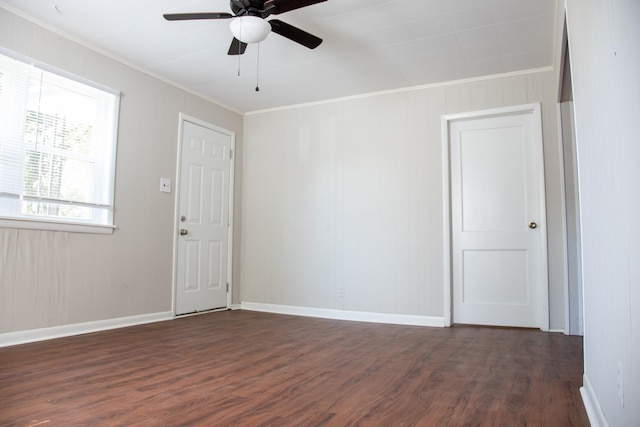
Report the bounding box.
[241,71,565,329]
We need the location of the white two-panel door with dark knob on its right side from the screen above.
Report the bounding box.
[449,106,547,328]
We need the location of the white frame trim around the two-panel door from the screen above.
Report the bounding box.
[441,103,549,331]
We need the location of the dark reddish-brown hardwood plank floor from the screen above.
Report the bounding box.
[0,311,589,427]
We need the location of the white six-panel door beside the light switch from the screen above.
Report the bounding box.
[176,120,233,314]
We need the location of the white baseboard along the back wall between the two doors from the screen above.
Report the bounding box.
[240,302,445,328]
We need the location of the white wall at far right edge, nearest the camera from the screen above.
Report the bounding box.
[566,0,640,426]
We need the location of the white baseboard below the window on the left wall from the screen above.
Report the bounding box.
[0,311,174,347]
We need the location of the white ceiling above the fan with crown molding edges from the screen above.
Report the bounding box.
[0,0,557,113]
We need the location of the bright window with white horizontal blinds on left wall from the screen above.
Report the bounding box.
[0,51,119,234]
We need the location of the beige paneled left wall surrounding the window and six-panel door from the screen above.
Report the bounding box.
[0,8,242,333]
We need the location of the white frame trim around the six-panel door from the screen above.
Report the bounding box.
[171,113,236,317]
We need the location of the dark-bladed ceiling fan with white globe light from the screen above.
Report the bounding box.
[163,0,327,55]
